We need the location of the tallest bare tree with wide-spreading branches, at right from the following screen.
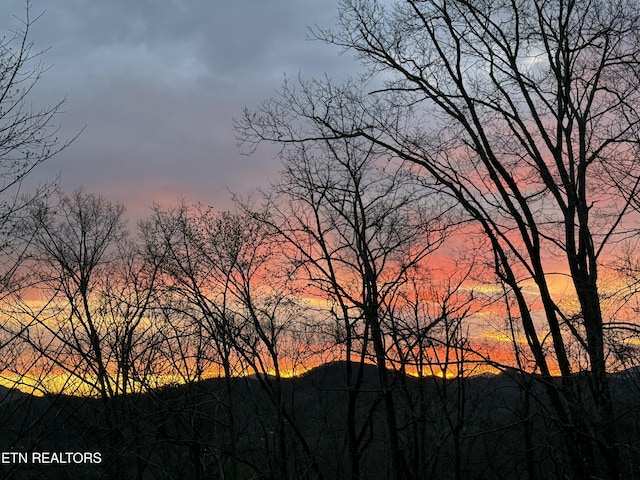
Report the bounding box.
[239,0,640,478]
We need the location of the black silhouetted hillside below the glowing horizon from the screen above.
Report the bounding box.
[0,363,640,480]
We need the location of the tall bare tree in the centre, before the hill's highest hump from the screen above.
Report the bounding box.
[239,131,450,479]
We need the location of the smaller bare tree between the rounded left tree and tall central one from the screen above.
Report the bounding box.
[140,200,252,478]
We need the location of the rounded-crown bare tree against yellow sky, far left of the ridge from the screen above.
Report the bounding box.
[5,190,180,478]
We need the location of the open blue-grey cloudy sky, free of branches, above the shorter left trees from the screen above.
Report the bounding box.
[0,0,357,217]
